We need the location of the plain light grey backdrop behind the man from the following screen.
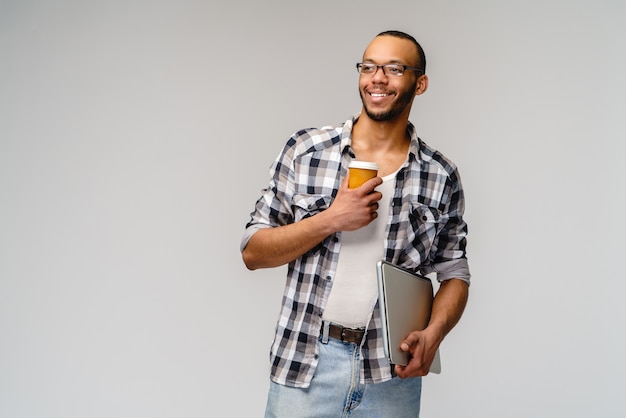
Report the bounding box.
[0,0,626,418]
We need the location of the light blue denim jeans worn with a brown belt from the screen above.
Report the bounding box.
[265,338,422,418]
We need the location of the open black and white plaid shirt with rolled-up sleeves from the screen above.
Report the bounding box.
[241,115,470,387]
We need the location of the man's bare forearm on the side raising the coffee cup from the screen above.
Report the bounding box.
[242,212,336,270]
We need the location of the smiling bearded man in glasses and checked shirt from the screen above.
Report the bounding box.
[241,31,470,418]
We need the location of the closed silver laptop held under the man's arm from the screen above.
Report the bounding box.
[376,260,441,373]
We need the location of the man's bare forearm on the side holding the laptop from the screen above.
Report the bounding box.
[428,279,469,342]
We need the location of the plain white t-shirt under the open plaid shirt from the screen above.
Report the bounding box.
[322,171,397,328]
